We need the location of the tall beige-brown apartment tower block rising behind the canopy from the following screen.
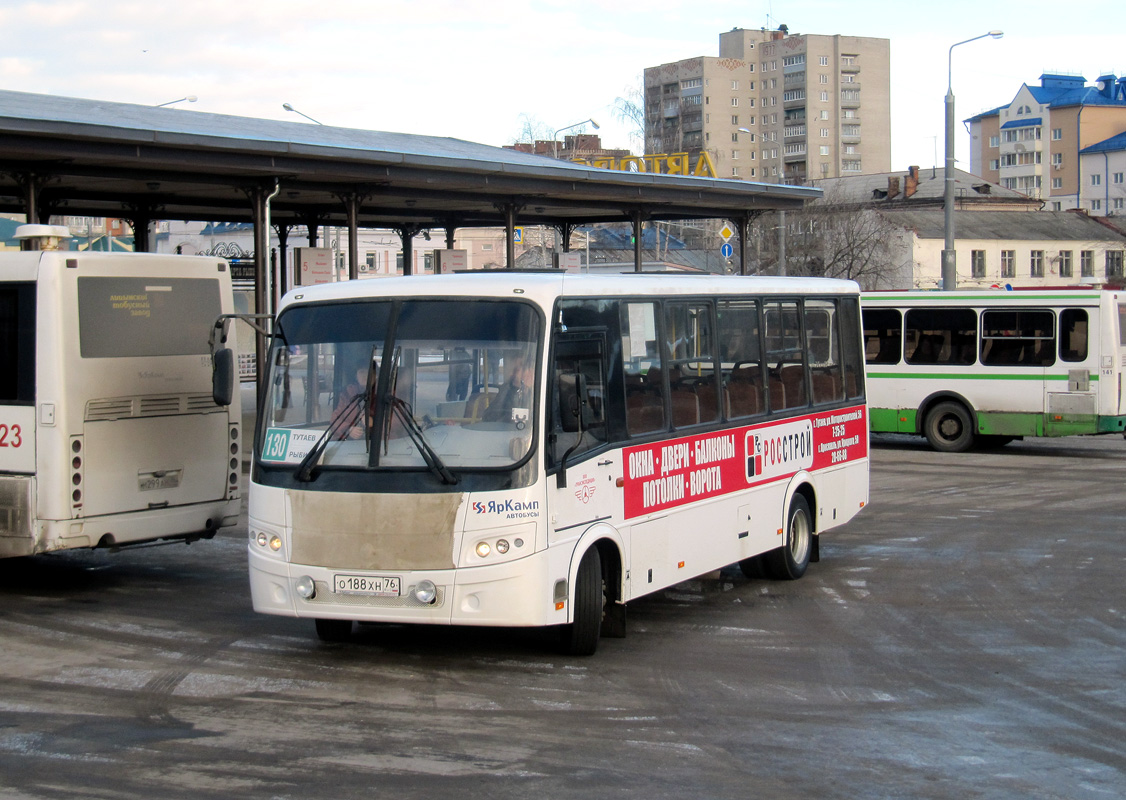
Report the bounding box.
[644,25,891,184]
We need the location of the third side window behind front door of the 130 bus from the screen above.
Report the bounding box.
[717,300,767,419]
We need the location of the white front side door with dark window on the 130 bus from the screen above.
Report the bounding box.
[545,331,622,542]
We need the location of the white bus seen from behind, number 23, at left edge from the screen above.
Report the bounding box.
[0,226,241,557]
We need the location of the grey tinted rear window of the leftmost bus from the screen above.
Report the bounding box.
[78,277,223,358]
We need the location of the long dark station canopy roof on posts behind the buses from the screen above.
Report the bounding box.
[0,91,820,229]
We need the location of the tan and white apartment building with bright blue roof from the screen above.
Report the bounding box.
[966,74,1126,215]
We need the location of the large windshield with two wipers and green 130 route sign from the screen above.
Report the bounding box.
[259,299,542,482]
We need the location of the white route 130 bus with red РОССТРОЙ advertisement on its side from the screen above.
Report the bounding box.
[249,272,868,654]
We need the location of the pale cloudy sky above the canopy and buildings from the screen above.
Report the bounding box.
[0,0,1126,170]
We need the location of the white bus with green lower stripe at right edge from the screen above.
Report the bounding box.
[861,288,1126,452]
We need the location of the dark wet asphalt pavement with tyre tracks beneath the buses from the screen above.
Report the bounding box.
[0,436,1126,800]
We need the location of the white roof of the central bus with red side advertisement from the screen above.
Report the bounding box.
[279,269,859,310]
